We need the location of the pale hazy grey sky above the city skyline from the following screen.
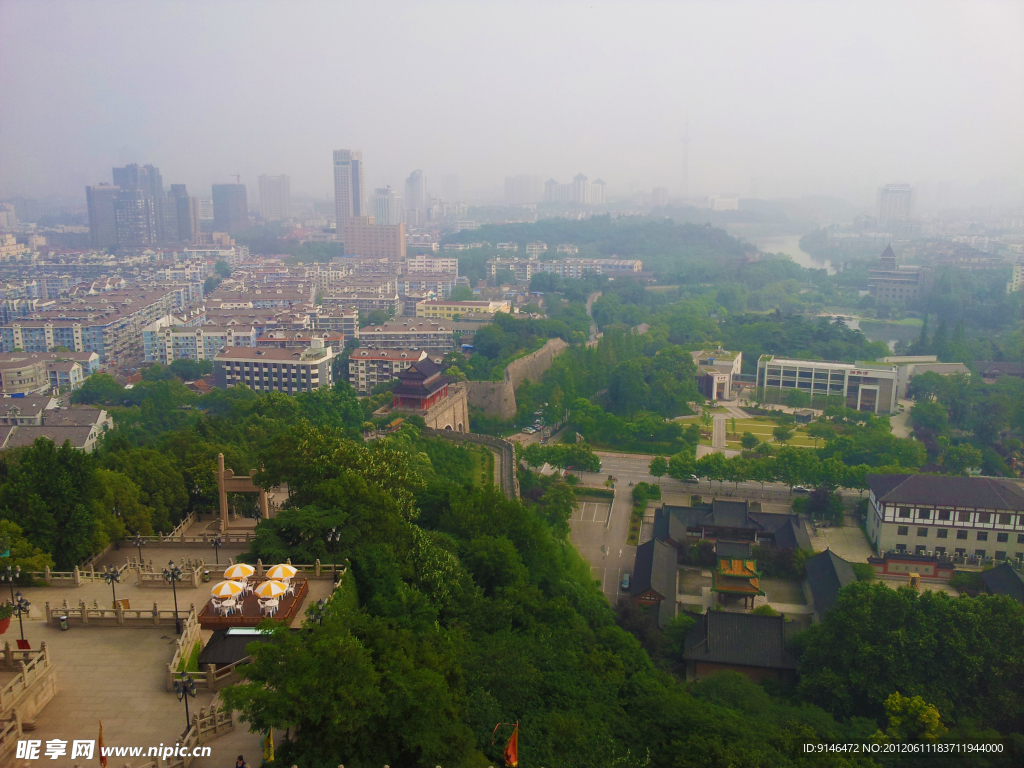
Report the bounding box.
[0,0,1024,204]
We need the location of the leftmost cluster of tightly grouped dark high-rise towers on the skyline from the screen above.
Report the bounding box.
[85,163,199,248]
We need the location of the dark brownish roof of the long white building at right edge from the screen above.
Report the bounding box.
[867,474,1024,512]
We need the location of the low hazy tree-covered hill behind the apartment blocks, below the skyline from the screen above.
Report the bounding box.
[445,216,755,279]
